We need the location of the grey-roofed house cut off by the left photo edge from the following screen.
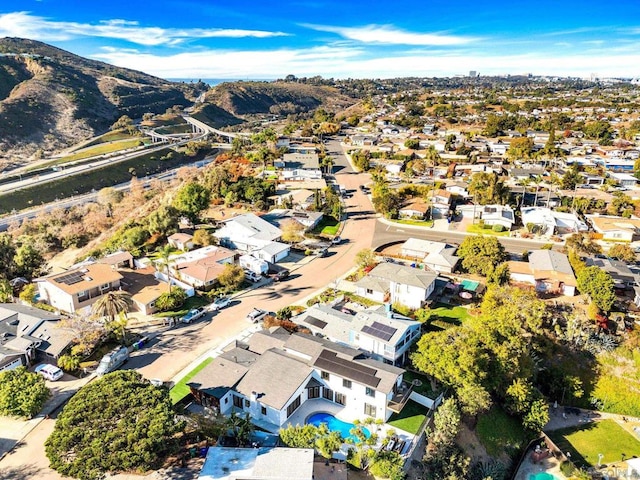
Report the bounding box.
[0,303,76,372]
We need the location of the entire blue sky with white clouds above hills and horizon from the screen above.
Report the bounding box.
[0,0,640,79]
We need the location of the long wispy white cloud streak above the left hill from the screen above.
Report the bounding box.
[0,12,287,46]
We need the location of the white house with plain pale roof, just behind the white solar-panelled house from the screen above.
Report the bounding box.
[356,263,438,309]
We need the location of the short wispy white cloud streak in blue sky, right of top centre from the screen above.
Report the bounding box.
[304,24,477,46]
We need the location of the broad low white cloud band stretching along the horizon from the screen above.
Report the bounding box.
[94,47,640,79]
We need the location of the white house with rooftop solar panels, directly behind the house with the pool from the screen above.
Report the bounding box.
[291,304,420,366]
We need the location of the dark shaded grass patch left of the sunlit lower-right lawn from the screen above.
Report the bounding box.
[476,407,527,457]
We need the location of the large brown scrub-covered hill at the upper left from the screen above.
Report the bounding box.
[0,38,202,168]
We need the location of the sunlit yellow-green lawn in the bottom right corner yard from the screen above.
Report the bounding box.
[548,419,640,467]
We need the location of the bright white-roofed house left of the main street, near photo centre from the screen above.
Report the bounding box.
[214,213,291,263]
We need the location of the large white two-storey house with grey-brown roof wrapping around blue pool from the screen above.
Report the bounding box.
[188,328,404,432]
